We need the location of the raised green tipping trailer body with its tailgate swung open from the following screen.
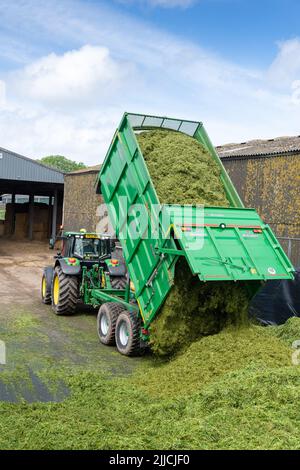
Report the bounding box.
[95,113,294,353]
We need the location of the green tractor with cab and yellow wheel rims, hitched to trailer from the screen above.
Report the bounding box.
[41,230,127,315]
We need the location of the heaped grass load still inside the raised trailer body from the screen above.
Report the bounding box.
[137,130,229,207]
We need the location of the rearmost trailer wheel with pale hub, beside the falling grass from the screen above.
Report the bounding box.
[115,310,141,356]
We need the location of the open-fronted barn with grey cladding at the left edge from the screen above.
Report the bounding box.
[0,148,64,241]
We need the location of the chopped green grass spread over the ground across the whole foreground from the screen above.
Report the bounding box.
[0,318,300,450]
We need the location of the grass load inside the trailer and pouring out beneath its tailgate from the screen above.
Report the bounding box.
[137,130,248,356]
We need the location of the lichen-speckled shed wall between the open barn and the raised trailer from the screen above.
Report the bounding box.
[63,165,103,232]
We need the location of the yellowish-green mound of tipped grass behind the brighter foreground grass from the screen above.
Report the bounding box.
[138,325,292,398]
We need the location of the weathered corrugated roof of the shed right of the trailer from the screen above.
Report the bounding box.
[216,136,300,158]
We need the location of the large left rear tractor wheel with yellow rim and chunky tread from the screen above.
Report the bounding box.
[52,267,78,315]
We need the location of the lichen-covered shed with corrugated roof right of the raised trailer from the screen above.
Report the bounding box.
[216,136,300,265]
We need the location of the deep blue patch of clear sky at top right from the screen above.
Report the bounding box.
[112,0,300,66]
